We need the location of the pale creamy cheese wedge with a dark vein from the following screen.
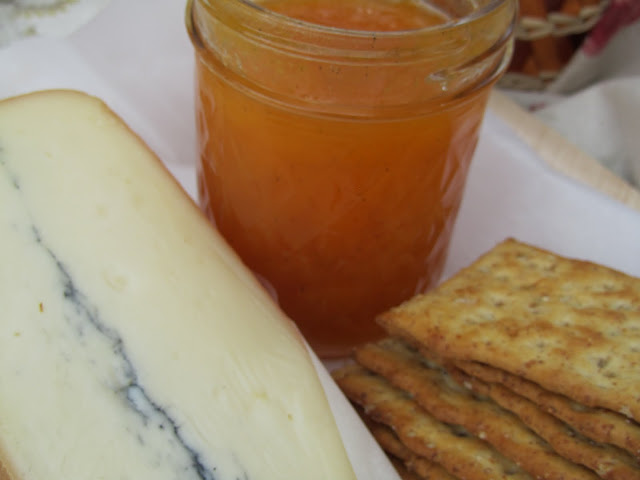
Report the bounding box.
[0,91,355,480]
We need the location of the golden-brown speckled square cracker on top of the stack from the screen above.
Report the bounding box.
[379,239,640,421]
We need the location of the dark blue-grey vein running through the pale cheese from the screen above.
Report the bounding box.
[0,153,240,480]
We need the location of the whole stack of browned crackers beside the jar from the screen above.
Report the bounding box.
[334,240,640,480]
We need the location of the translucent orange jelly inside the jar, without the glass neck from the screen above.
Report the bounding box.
[197,0,488,357]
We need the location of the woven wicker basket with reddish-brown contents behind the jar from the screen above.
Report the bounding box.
[499,0,609,91]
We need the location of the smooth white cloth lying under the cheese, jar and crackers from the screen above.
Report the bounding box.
[0,0,640,480]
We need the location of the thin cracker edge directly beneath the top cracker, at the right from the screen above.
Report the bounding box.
[455,361,640,458]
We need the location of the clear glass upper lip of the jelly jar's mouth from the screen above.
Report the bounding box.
[191,0,519,61]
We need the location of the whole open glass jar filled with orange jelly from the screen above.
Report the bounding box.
[187,0,517,358]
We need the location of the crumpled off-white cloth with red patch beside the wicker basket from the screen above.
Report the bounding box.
[505,19,640,187]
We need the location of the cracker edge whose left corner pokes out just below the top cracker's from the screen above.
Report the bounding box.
[355,339,597,480]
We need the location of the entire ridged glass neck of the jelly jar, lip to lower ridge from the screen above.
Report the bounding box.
[186,0,518,117]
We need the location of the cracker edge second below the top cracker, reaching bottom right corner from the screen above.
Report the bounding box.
[451,370,640,480]
